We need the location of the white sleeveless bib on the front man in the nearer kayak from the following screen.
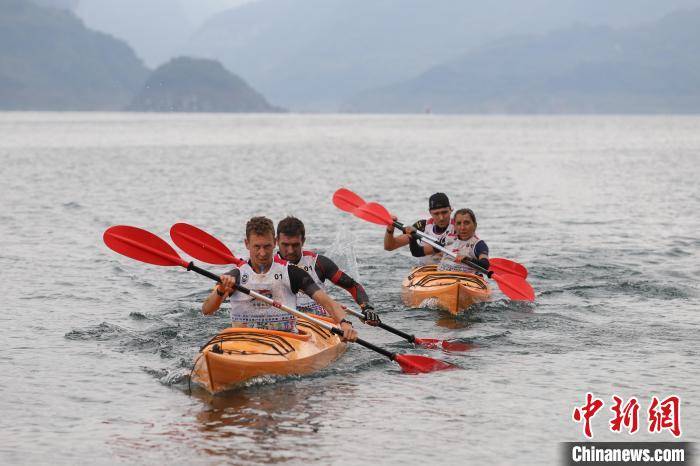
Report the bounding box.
[230,256,297,332]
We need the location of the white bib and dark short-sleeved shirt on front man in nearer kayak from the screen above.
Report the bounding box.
[227,256,319,333]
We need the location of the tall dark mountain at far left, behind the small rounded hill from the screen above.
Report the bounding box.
[0,0,148,110]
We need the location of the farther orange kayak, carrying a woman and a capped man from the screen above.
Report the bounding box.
[401,264,491,314]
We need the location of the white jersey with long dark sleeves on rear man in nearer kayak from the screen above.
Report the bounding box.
[282,251,369,316]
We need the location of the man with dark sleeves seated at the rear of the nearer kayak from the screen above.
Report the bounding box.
[277,216,380,326]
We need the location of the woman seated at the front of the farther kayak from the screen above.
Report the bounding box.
[410,209,490,274]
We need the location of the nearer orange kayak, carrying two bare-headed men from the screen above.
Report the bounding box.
[192,316,346,394]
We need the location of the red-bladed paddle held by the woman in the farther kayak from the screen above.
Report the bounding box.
[353,202,535,301]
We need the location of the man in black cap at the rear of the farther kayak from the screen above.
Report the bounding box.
[384,193,455,265]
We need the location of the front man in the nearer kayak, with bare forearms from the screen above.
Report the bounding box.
[202,217,357,341]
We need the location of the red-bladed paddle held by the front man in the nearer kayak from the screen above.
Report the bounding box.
[103,225,457,374]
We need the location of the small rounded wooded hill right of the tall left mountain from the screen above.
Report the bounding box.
[128,57,282,113]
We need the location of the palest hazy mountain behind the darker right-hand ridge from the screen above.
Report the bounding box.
[184,0,700,111]
